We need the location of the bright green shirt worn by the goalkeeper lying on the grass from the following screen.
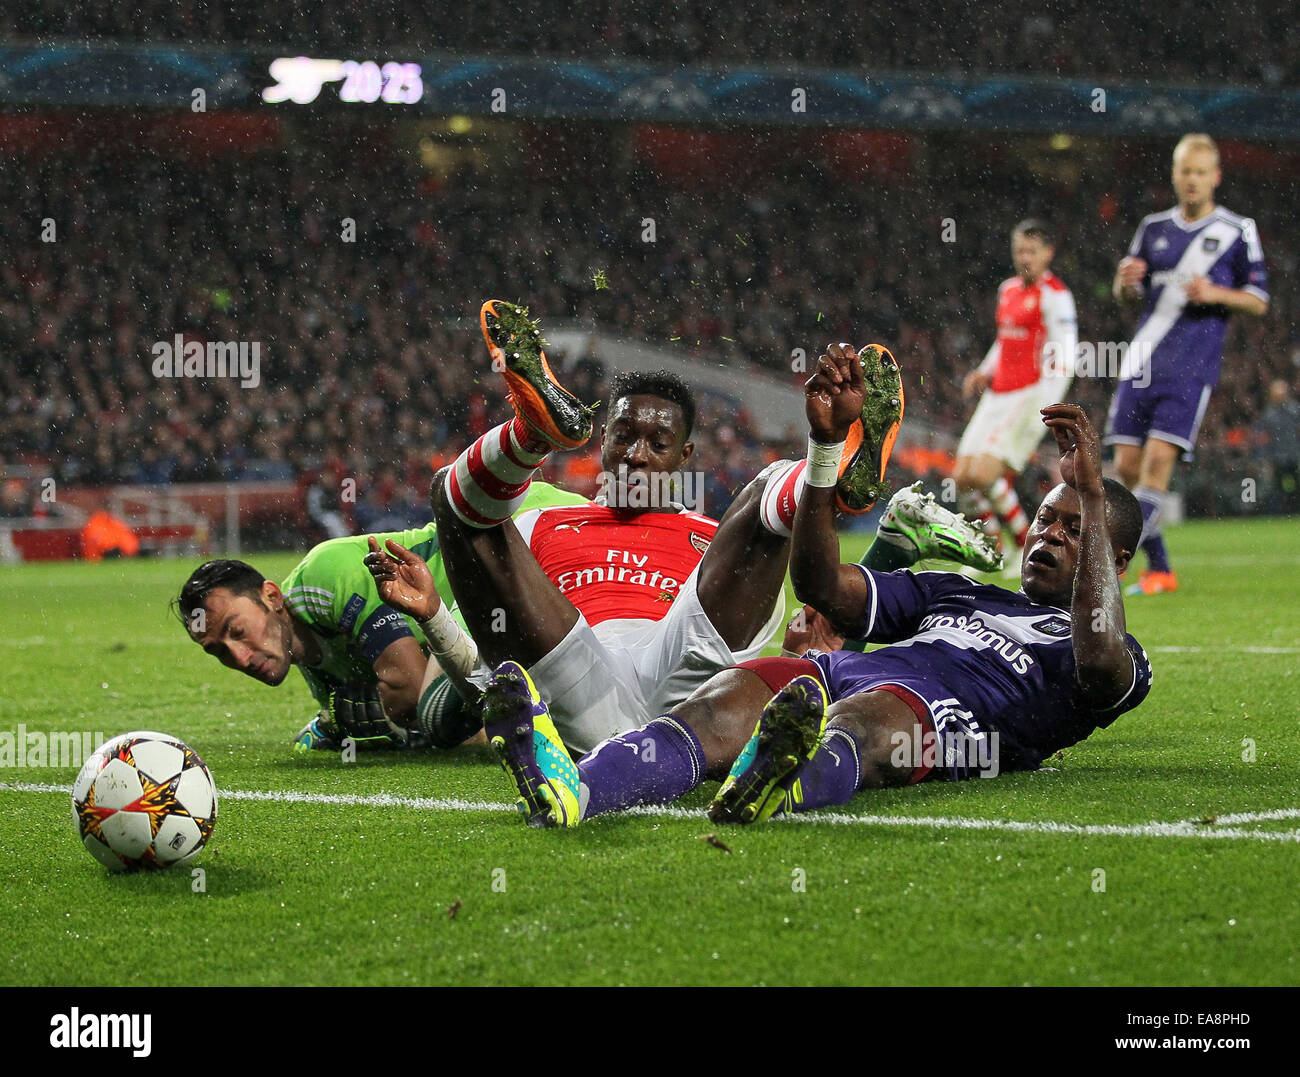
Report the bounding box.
[280,483,586,706]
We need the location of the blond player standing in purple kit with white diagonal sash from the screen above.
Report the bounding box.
[1105,134,1269,594]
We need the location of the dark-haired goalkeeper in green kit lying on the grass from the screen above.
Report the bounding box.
[172,483,586,751]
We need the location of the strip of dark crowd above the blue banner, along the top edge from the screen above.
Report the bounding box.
[0,0,1300,86]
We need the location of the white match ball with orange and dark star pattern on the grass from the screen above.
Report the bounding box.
[73,732,217,871]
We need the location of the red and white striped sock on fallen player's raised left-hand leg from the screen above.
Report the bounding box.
[445,419,550,528]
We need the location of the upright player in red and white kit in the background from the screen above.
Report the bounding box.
[953,219,1078,564]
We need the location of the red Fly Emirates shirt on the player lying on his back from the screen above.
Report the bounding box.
[515,503,718,624]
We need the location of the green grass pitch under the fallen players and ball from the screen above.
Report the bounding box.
[0,520,1300,986]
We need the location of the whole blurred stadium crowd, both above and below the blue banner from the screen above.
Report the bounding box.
[0,0,1300,529]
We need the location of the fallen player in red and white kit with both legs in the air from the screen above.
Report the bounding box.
[367,300,902,775]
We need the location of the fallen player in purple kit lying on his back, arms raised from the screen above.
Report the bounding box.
[478,356,1151,826]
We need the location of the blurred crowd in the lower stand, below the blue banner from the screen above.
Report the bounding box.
[0,128,1300,528]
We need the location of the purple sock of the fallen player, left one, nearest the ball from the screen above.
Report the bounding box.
[577,714,705,818]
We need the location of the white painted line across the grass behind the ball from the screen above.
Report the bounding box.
[0,782,1300,843]
